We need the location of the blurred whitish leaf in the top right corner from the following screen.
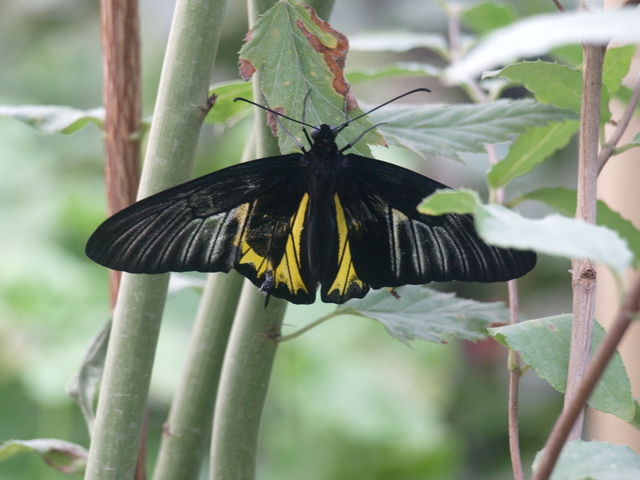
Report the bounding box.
[445,7,640,81]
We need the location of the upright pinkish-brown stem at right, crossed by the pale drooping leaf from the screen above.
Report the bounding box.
[565,45,606,440]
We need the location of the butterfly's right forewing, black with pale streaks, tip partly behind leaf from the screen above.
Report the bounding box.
[323,155,536,288]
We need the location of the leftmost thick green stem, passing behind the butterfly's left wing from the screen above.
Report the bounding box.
[85,0,225,480]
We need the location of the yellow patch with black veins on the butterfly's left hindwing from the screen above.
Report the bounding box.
[233,193,309,294]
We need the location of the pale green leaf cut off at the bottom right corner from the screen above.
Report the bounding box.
[533,440,640,480]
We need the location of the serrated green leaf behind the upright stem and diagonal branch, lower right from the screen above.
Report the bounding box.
[489,314,635,421]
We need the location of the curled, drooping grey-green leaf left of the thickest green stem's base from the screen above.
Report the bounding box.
[66,320,111,435]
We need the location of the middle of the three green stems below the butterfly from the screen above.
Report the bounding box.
[153,272,243,480]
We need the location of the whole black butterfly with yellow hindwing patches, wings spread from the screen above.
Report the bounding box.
[86,89,536,304]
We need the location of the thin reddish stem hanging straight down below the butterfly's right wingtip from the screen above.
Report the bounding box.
[508,280,524,480]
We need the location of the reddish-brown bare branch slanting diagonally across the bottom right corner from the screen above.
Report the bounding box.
[531,271,640,480]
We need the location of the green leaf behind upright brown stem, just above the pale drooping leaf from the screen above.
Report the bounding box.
[515,188,640,268]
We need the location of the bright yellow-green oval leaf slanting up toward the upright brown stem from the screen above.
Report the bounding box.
[487,120,580,188]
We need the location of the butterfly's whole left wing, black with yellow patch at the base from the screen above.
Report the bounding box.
[86,154,315,303]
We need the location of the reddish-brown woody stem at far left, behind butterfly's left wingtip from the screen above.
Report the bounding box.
[101,0,141,307]
